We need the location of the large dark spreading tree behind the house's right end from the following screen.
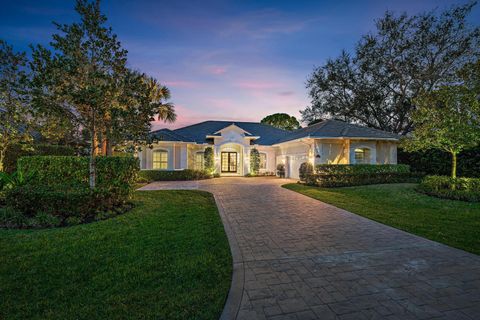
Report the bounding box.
[301,2,480,134]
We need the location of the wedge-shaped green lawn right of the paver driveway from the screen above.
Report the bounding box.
[284,184,480,254]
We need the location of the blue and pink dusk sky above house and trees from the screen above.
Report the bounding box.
[0,0,480,129]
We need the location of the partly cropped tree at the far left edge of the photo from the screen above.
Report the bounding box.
[0,39,32,172]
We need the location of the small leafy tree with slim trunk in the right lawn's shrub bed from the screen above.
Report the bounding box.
[404,62,480,178]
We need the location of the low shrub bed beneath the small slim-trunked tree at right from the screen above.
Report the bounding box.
[417,176,480,202]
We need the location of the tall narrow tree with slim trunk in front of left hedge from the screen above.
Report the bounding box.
[31,0,127,188]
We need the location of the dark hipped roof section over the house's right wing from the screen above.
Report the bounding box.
[276,120,400,143]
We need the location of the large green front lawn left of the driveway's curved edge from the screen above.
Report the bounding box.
[0,191,232,319]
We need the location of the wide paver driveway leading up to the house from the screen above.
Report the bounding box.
[143,178,480,319]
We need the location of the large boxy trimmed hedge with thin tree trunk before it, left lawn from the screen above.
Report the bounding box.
[5,156,139,223]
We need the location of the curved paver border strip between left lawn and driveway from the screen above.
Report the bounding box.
[213,195,245,320]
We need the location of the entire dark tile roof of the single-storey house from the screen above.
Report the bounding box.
[151,120,399,145]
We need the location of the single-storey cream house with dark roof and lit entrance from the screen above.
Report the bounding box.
[138,120,399,178]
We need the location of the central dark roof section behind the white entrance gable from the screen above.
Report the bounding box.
[173,120,290,145]
